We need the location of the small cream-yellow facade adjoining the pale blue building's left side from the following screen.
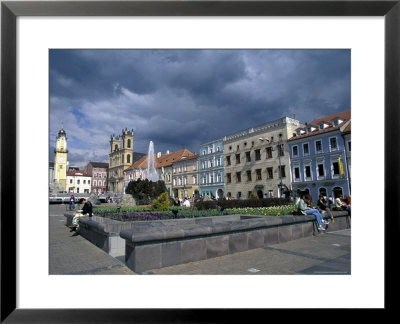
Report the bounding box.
[172,154,200,199]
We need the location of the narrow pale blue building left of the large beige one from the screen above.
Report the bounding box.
[199,139,225,199]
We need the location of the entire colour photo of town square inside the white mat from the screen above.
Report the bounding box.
[49,50,351,275]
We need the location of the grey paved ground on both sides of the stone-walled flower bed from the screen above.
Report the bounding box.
[49,205,351,275]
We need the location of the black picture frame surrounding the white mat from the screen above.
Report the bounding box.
[0,0,400,323]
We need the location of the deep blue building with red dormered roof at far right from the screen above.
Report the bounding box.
[288,110,351,202]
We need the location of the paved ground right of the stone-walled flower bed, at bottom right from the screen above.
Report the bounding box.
[146,230,351,275]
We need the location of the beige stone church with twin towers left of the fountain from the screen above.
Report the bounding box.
[108,129,134,194]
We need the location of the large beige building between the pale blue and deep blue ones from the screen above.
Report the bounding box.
[223,117,301,199]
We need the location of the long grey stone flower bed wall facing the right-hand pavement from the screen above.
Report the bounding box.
[120,212,350,273]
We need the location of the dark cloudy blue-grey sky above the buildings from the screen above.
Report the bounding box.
[49,50,351,167]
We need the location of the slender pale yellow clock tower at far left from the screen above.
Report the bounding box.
[53,128,68,191]
